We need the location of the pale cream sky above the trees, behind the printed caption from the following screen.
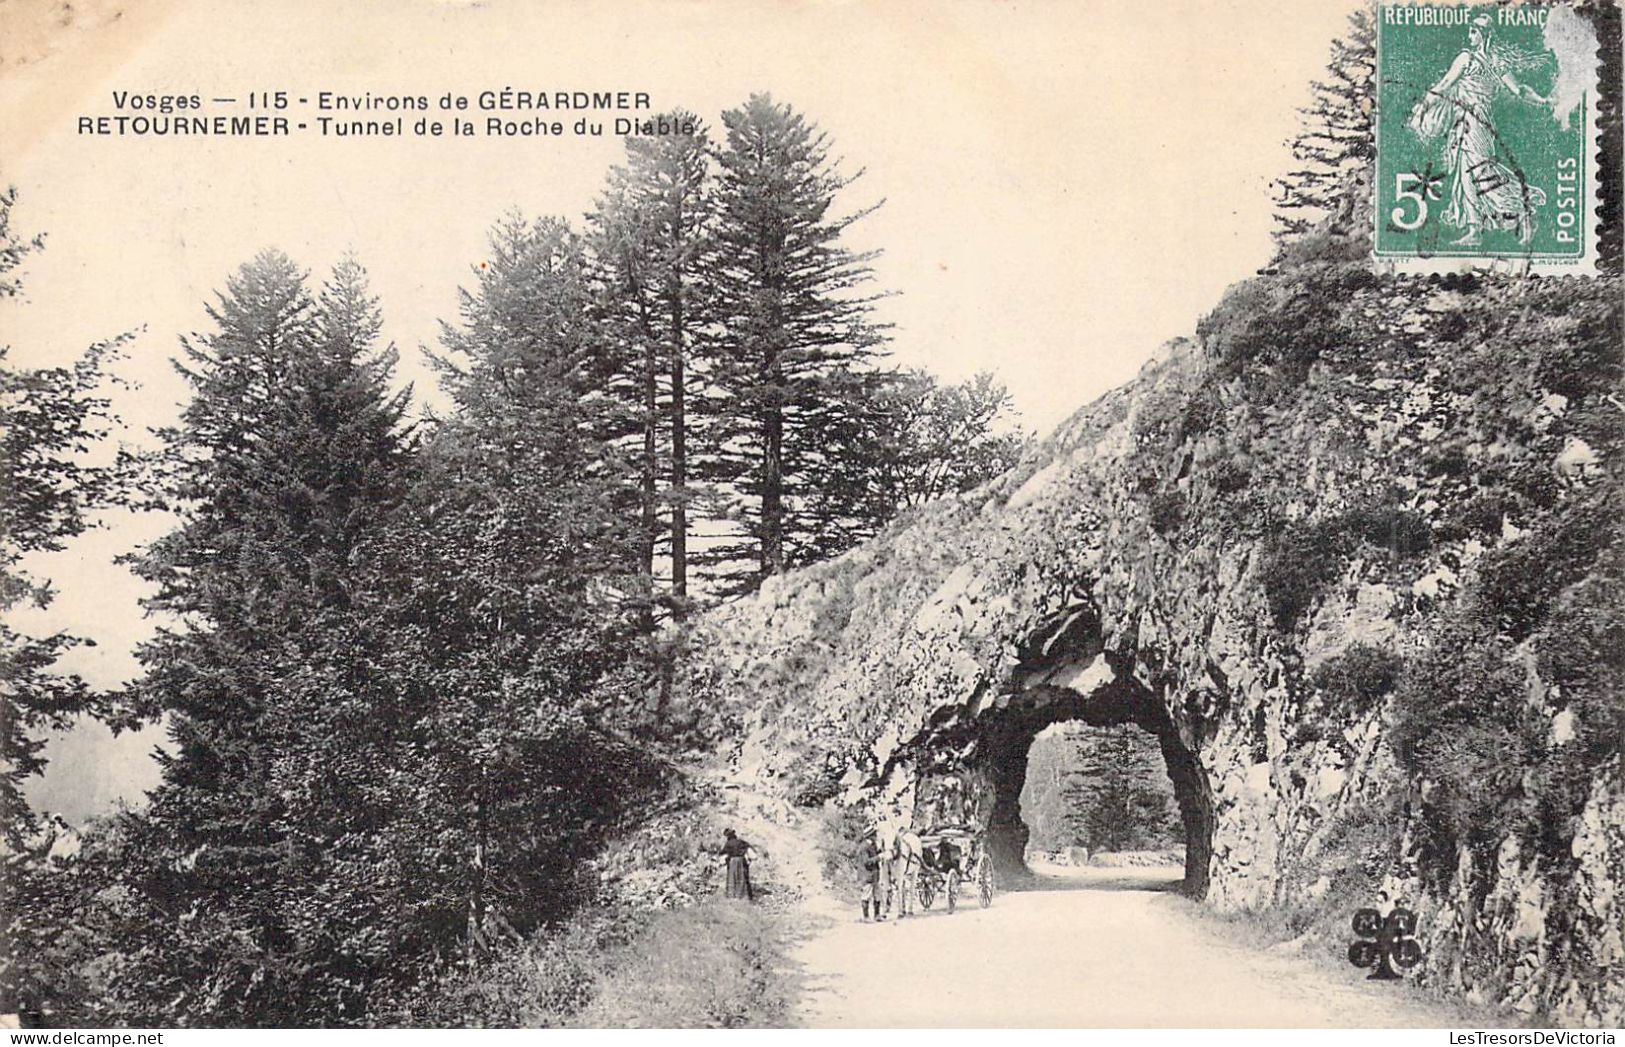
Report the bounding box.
[0,0,1354,819]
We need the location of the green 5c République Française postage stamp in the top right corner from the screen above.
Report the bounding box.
[1373,3,1597,273]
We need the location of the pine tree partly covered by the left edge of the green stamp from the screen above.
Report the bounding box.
[1272,10,1376,242]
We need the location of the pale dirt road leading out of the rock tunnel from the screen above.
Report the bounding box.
[798,868,1471,1027]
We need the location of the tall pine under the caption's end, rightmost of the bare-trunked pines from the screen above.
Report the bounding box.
[705,94,882,592]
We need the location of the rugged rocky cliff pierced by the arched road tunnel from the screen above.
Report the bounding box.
[674,232,1625,1023]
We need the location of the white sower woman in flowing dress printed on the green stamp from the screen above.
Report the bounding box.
[1407,13,1550,245]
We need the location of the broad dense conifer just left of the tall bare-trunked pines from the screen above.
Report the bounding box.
[377,216,640,956]
